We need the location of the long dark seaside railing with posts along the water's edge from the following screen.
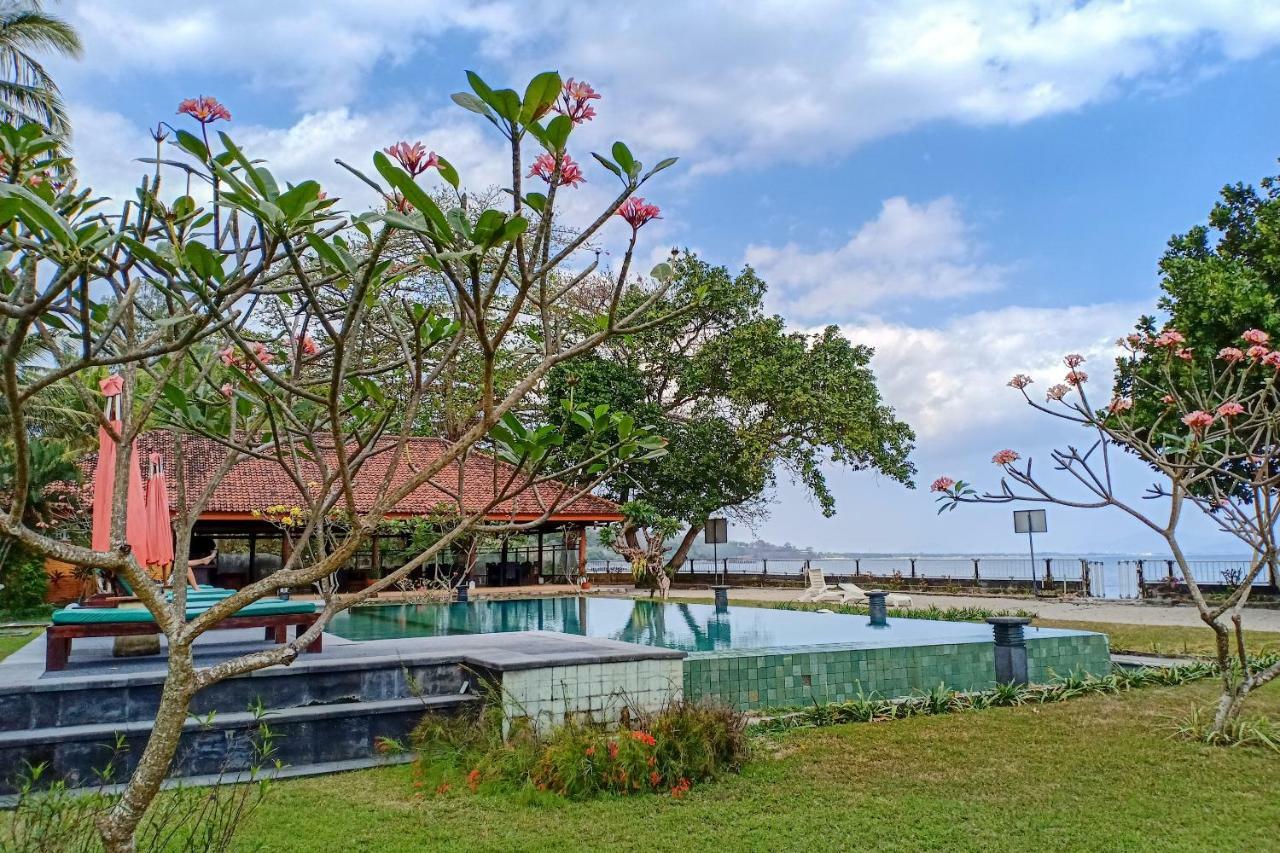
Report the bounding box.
[586,556,1274,598]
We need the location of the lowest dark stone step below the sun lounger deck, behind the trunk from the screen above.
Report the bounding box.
[0,693,479,795]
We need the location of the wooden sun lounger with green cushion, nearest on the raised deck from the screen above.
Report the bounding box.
[45,598,321,671]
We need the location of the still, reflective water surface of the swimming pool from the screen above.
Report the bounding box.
[328,596,1079,652]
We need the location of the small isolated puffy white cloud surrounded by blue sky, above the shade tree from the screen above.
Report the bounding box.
[746,196,1006,321]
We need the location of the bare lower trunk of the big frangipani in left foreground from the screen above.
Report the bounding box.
[97,644,196,853]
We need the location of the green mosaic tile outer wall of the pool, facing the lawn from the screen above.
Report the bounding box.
[685,634,1111,711]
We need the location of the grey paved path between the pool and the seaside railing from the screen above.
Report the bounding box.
[634,587,1280,631]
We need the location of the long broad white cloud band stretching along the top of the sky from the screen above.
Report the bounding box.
[59,0,1280,172]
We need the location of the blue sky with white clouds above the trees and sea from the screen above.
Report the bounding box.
[50,0,1280,553]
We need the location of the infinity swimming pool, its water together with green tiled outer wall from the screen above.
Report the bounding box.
[329,596,1111,711]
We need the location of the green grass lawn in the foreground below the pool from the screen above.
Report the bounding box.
[238,683,1280,853]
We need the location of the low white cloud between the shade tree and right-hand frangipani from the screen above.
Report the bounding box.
[841,302,1149,440]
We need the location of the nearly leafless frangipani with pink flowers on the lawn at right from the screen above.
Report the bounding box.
[933,329,1280,735]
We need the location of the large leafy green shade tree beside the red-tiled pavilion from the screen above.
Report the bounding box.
[547,252,915,571]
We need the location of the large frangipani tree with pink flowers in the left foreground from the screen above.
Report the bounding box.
[0,72,680,850]
